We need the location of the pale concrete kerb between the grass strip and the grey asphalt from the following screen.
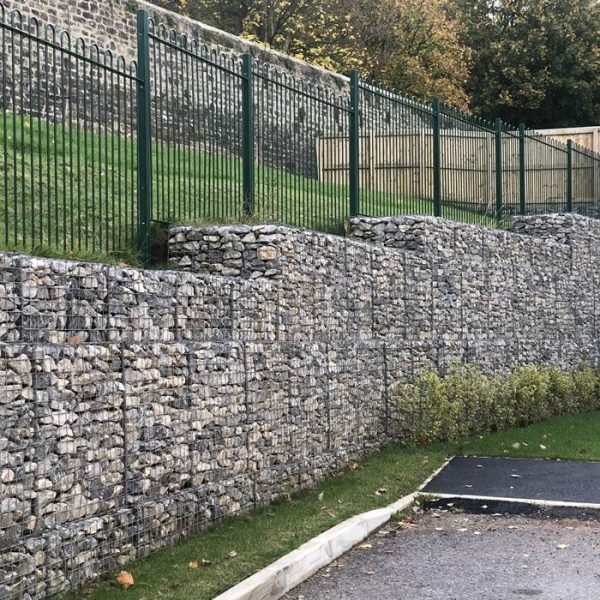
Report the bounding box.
[215,459,450,600]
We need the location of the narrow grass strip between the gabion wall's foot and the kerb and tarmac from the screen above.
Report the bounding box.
[67,413,600,600]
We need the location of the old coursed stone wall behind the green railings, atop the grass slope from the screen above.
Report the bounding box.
[0,0,430,186]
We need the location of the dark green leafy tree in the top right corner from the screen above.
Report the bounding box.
[448,0,600,127]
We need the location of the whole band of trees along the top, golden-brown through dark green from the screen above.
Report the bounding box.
[156,0,600,127]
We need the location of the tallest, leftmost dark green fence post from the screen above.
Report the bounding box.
[137,10,152,266]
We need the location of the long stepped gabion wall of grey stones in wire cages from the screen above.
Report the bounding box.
[0,216,600,598]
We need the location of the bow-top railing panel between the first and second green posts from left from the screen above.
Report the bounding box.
[149,21,243,223]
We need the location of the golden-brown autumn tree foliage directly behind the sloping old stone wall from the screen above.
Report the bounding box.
[152,0,469,103]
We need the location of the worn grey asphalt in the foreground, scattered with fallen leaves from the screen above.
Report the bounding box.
[285,509,600,600]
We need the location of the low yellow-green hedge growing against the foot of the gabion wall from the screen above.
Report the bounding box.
[391,366,600,444]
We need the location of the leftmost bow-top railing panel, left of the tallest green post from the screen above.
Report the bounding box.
[0,5,137,252]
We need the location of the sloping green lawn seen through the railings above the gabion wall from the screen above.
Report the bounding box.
[0,111,495,260]
